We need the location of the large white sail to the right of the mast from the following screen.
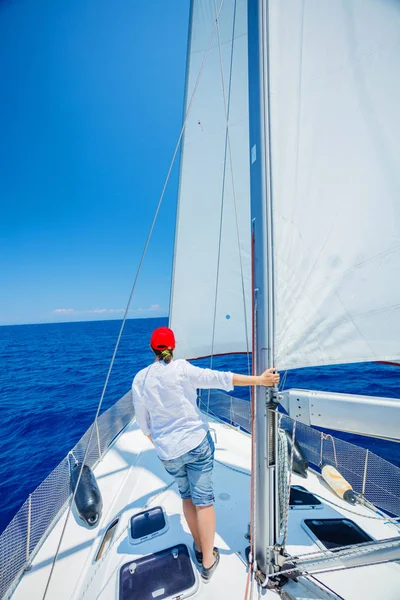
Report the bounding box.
[269,0,400,369]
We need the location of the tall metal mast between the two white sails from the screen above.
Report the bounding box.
[248,0,279,574]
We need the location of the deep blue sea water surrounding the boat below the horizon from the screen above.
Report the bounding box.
[0,318,400,532]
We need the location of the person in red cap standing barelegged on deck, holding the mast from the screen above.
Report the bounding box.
[132,327,279,582]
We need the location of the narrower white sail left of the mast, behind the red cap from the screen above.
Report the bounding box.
[170,0,251,358]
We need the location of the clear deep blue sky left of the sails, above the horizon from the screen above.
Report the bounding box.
[0,0,189,324]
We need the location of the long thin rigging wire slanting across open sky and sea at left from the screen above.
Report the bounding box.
[42,0,228,600]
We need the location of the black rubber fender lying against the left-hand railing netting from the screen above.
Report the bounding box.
[71,463,103,527]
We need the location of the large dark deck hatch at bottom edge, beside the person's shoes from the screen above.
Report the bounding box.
[119,544,197,600]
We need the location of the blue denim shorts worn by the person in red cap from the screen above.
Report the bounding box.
[161,432,215,506]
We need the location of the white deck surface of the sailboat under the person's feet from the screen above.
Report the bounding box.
[12,423,400,600]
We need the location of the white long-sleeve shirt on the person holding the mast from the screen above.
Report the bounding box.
[132,359,233,460]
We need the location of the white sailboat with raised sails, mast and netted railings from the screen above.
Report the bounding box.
[0,0,400,600]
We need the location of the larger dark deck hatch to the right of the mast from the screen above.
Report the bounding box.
[304,519,373,551]
